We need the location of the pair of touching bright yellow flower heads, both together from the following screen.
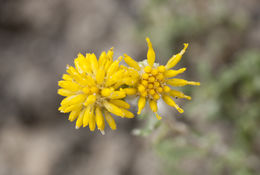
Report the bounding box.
[58,38,200,134]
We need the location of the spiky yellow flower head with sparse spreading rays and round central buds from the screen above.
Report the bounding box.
[124,38,200,120]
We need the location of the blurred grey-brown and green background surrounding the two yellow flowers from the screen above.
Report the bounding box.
[0,0,260,175]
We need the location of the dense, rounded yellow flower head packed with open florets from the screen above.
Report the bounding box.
[58,48,138,134]
